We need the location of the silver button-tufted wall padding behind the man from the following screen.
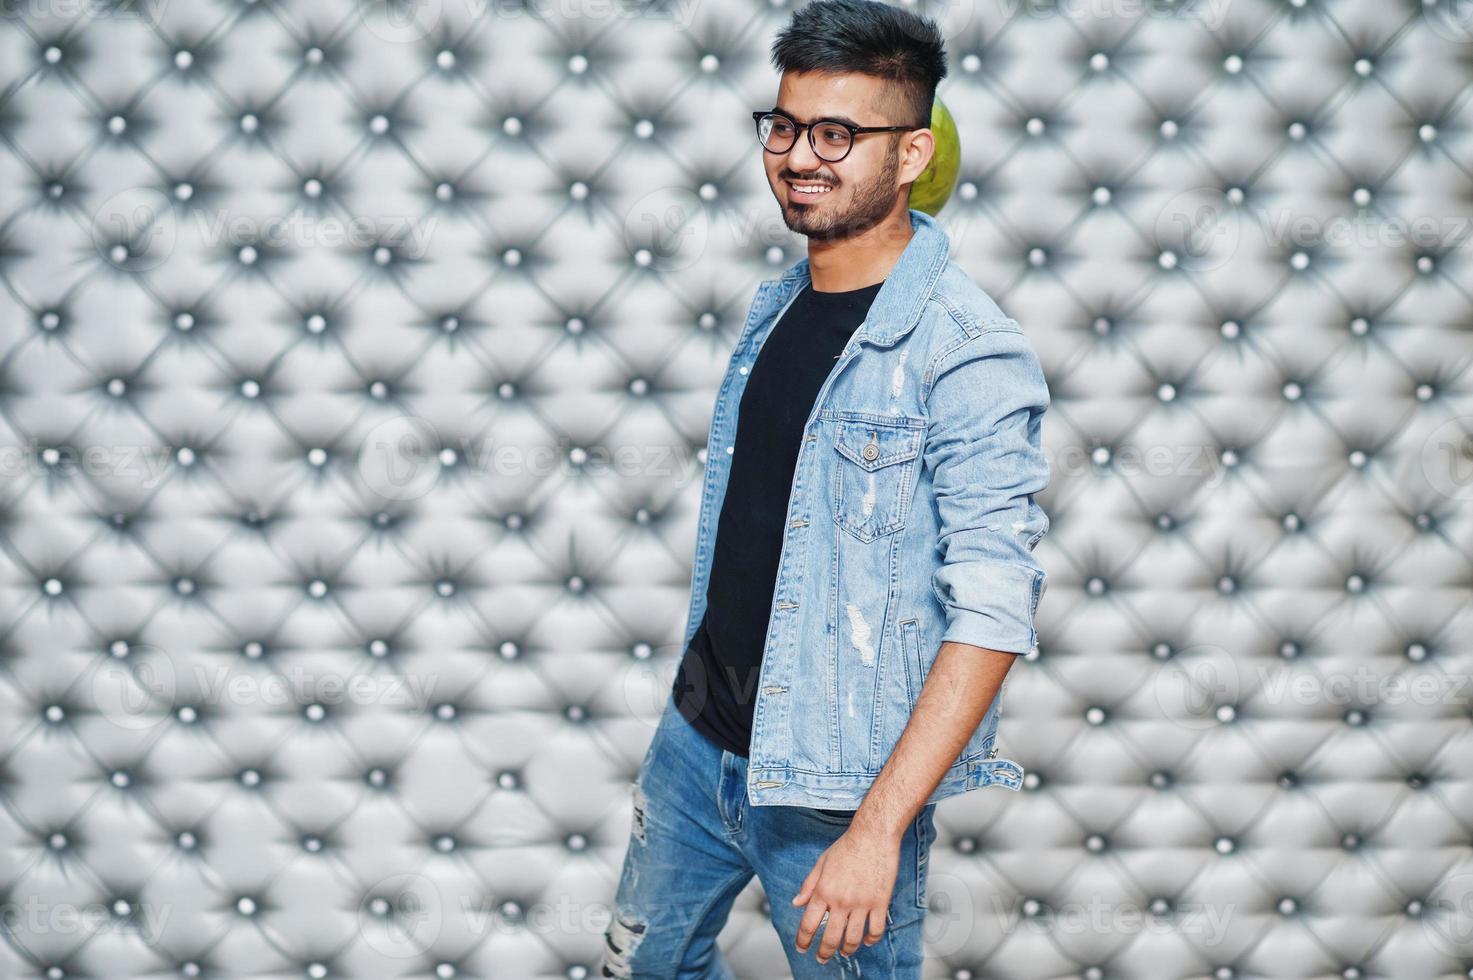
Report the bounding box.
[0,0,1473,980]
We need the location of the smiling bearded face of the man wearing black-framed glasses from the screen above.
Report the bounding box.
[762,72,931,239]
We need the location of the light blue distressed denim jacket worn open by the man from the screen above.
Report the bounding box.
[685,209,1049,809]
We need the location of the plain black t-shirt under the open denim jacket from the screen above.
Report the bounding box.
[672,281,884,756]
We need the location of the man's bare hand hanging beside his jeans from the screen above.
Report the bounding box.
[792,827,900,962]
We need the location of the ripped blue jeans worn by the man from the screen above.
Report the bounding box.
[600,699,935,980]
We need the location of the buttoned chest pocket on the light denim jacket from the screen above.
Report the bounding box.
[834,417,922,541]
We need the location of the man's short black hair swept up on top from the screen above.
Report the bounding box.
[772,0,946,128]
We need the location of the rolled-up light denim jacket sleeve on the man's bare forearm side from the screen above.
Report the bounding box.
[925,320,1049,653]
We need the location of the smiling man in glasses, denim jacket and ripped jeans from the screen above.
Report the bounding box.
[602,0,1049,977]
